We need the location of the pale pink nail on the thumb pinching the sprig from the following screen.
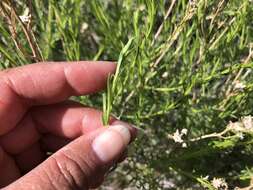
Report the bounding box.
[92,125,131,162]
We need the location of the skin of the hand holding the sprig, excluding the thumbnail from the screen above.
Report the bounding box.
[0,62,136,190]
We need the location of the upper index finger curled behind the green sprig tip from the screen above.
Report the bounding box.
[0,62,116,136]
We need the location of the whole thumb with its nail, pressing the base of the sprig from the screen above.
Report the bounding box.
[6,122,134,190]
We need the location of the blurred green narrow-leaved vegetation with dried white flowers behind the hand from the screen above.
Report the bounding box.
[0,0,253,189]
